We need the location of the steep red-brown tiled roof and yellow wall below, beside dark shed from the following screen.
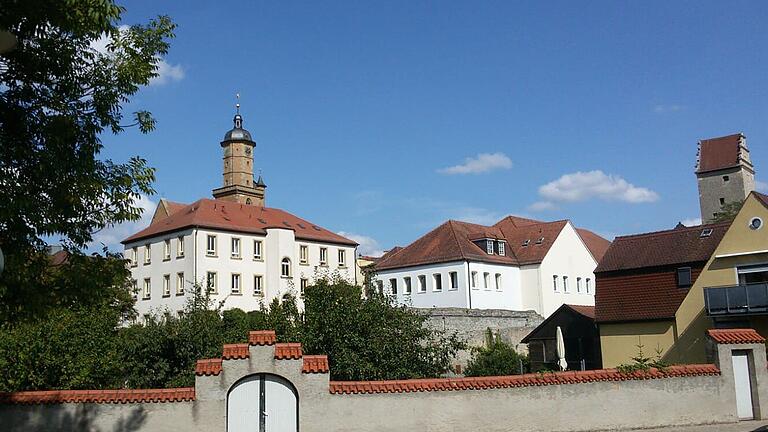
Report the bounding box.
[595,222,730,367]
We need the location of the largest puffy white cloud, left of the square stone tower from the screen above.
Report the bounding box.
[539,170,659,203]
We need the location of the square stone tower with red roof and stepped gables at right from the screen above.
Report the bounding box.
[696,133,755,223]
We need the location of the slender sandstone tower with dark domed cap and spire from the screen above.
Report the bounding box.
[213,104,267,207]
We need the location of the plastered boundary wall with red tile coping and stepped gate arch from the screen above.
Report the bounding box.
[0,332,768,432]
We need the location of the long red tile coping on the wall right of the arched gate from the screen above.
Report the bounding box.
[329,364,720,394]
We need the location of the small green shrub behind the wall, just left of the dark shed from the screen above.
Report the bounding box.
[465,329,529,376]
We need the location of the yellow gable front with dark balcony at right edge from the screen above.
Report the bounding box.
[667,192,768,363]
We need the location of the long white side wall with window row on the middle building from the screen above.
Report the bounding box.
[376,261,521,310]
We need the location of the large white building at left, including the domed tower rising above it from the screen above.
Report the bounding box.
[123,108,357,316]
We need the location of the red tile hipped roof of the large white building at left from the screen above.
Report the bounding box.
[122,198,357,246]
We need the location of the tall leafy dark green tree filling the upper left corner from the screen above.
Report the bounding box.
[0,0,175,320]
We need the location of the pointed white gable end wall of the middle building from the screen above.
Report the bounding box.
[538,222,597,318]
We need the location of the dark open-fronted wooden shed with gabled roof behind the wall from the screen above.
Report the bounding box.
[522,304,602,372]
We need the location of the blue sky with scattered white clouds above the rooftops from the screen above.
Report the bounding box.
[94,1,768,252]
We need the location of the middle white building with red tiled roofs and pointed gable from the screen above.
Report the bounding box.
[374,218,608,317]
